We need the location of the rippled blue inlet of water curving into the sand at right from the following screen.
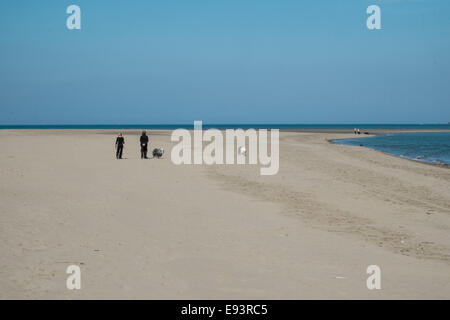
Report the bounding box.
[334,132,450,164]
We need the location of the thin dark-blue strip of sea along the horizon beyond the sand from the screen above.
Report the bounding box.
[0,122,450,131]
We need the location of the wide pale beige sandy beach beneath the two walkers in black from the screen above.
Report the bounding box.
[0,130,450,299]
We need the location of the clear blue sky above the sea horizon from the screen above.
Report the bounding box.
[0,0,450,124]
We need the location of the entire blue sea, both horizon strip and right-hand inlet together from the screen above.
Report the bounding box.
[0,123,450,164]
